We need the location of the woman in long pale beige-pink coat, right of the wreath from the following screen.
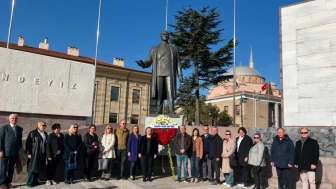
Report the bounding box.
[222,130,236,188]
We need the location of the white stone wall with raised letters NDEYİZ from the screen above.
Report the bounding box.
[0,48,94,117]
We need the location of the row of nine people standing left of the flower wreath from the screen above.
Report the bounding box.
[0,114,159,189]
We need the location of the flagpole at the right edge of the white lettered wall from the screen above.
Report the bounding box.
[91,0,102,124]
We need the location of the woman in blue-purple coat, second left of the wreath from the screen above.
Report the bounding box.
[127,125,141,180]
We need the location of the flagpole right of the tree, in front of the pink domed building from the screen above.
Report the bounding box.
[232,0,236,127]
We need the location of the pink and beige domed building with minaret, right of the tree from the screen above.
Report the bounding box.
[206,49,281,127]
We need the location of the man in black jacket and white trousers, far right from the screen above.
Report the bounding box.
[294,128,320,189]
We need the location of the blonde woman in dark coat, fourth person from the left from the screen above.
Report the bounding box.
[63,124,83,184]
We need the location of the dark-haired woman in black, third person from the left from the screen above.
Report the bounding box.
[46,123,64,186]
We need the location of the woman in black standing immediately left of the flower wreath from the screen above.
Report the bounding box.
[139,127,159,182]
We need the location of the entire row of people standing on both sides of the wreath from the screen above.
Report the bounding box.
[0,114,319,189]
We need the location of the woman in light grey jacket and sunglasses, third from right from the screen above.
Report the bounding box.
[248,133,266,189]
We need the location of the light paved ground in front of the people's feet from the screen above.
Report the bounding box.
[11,177,276,189]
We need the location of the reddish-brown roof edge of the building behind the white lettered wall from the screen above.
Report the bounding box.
[0,41,151,74]
